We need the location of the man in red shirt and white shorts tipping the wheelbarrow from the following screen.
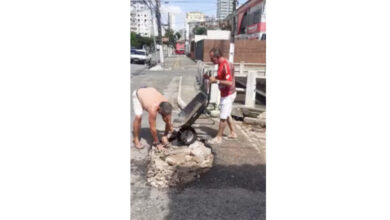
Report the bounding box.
[205,48,237,144]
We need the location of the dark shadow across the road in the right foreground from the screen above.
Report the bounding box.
[164,162,266,220]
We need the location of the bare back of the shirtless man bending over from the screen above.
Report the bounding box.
[137,88,168,113]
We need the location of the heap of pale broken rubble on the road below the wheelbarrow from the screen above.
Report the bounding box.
[147,141,214,188]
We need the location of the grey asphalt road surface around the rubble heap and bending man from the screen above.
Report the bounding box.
[130,56,265,220]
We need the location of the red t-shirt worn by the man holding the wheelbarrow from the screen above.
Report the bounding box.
[216,59,236,97]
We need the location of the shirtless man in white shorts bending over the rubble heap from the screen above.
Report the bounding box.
[132,87,173,150]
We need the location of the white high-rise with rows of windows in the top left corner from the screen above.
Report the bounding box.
[130,1,153,37]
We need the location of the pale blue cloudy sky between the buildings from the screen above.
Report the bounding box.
[161,0,246,31]
